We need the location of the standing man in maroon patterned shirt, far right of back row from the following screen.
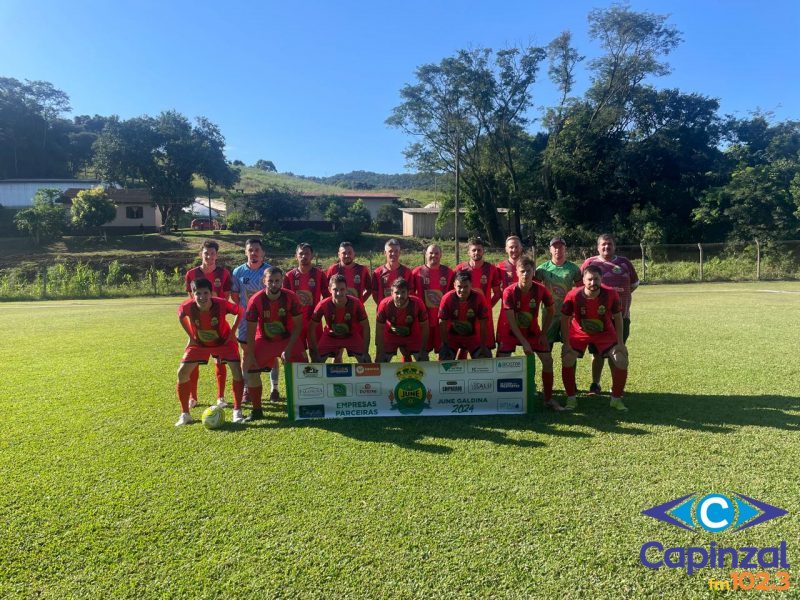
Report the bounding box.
[581,233,639,395]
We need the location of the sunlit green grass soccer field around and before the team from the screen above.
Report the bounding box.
[0,282,800,598]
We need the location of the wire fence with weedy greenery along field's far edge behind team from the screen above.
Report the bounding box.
[0,240,800,300]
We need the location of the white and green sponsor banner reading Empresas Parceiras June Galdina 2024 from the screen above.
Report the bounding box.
[285,356,536,420]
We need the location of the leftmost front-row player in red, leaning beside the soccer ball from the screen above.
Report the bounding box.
[175,279,244,426]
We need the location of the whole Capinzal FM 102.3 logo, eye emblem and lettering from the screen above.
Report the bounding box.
[639,493,790,590]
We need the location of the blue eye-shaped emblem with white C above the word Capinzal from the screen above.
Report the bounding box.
[642,493,787,533]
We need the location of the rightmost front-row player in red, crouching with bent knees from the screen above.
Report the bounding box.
[561,265,628,410]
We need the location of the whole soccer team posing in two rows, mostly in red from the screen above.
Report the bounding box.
[176,234,639,425]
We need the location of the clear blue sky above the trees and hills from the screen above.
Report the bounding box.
[0,0,800,175]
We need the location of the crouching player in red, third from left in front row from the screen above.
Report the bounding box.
[308,275,370,363]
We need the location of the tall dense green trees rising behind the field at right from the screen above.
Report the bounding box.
[387,5,800,244]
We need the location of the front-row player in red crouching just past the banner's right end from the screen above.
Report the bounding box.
[497,256,566,412]
